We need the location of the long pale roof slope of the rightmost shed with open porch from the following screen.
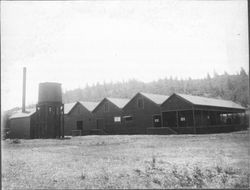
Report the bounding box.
[176,94,246,109]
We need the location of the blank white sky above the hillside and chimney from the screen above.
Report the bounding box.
[1,0,248,110]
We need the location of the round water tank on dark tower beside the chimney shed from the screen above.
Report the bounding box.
[35,82,64,138]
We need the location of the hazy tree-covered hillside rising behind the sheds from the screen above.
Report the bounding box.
[63,68,249,107]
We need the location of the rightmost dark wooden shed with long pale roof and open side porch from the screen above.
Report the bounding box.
[161,93,245,133]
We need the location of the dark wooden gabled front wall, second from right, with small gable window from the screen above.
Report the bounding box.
[123,94,161,134]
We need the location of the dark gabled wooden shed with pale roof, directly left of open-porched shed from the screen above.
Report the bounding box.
[123,92,168,134]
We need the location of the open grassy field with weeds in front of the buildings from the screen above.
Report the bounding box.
[2,131,250,189]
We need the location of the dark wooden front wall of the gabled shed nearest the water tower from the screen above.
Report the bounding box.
[64,103,95,135]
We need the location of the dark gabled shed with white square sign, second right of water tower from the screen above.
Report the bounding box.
[93,98,129,134]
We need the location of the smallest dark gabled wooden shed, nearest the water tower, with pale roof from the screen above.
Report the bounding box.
[64,101,98,135]
